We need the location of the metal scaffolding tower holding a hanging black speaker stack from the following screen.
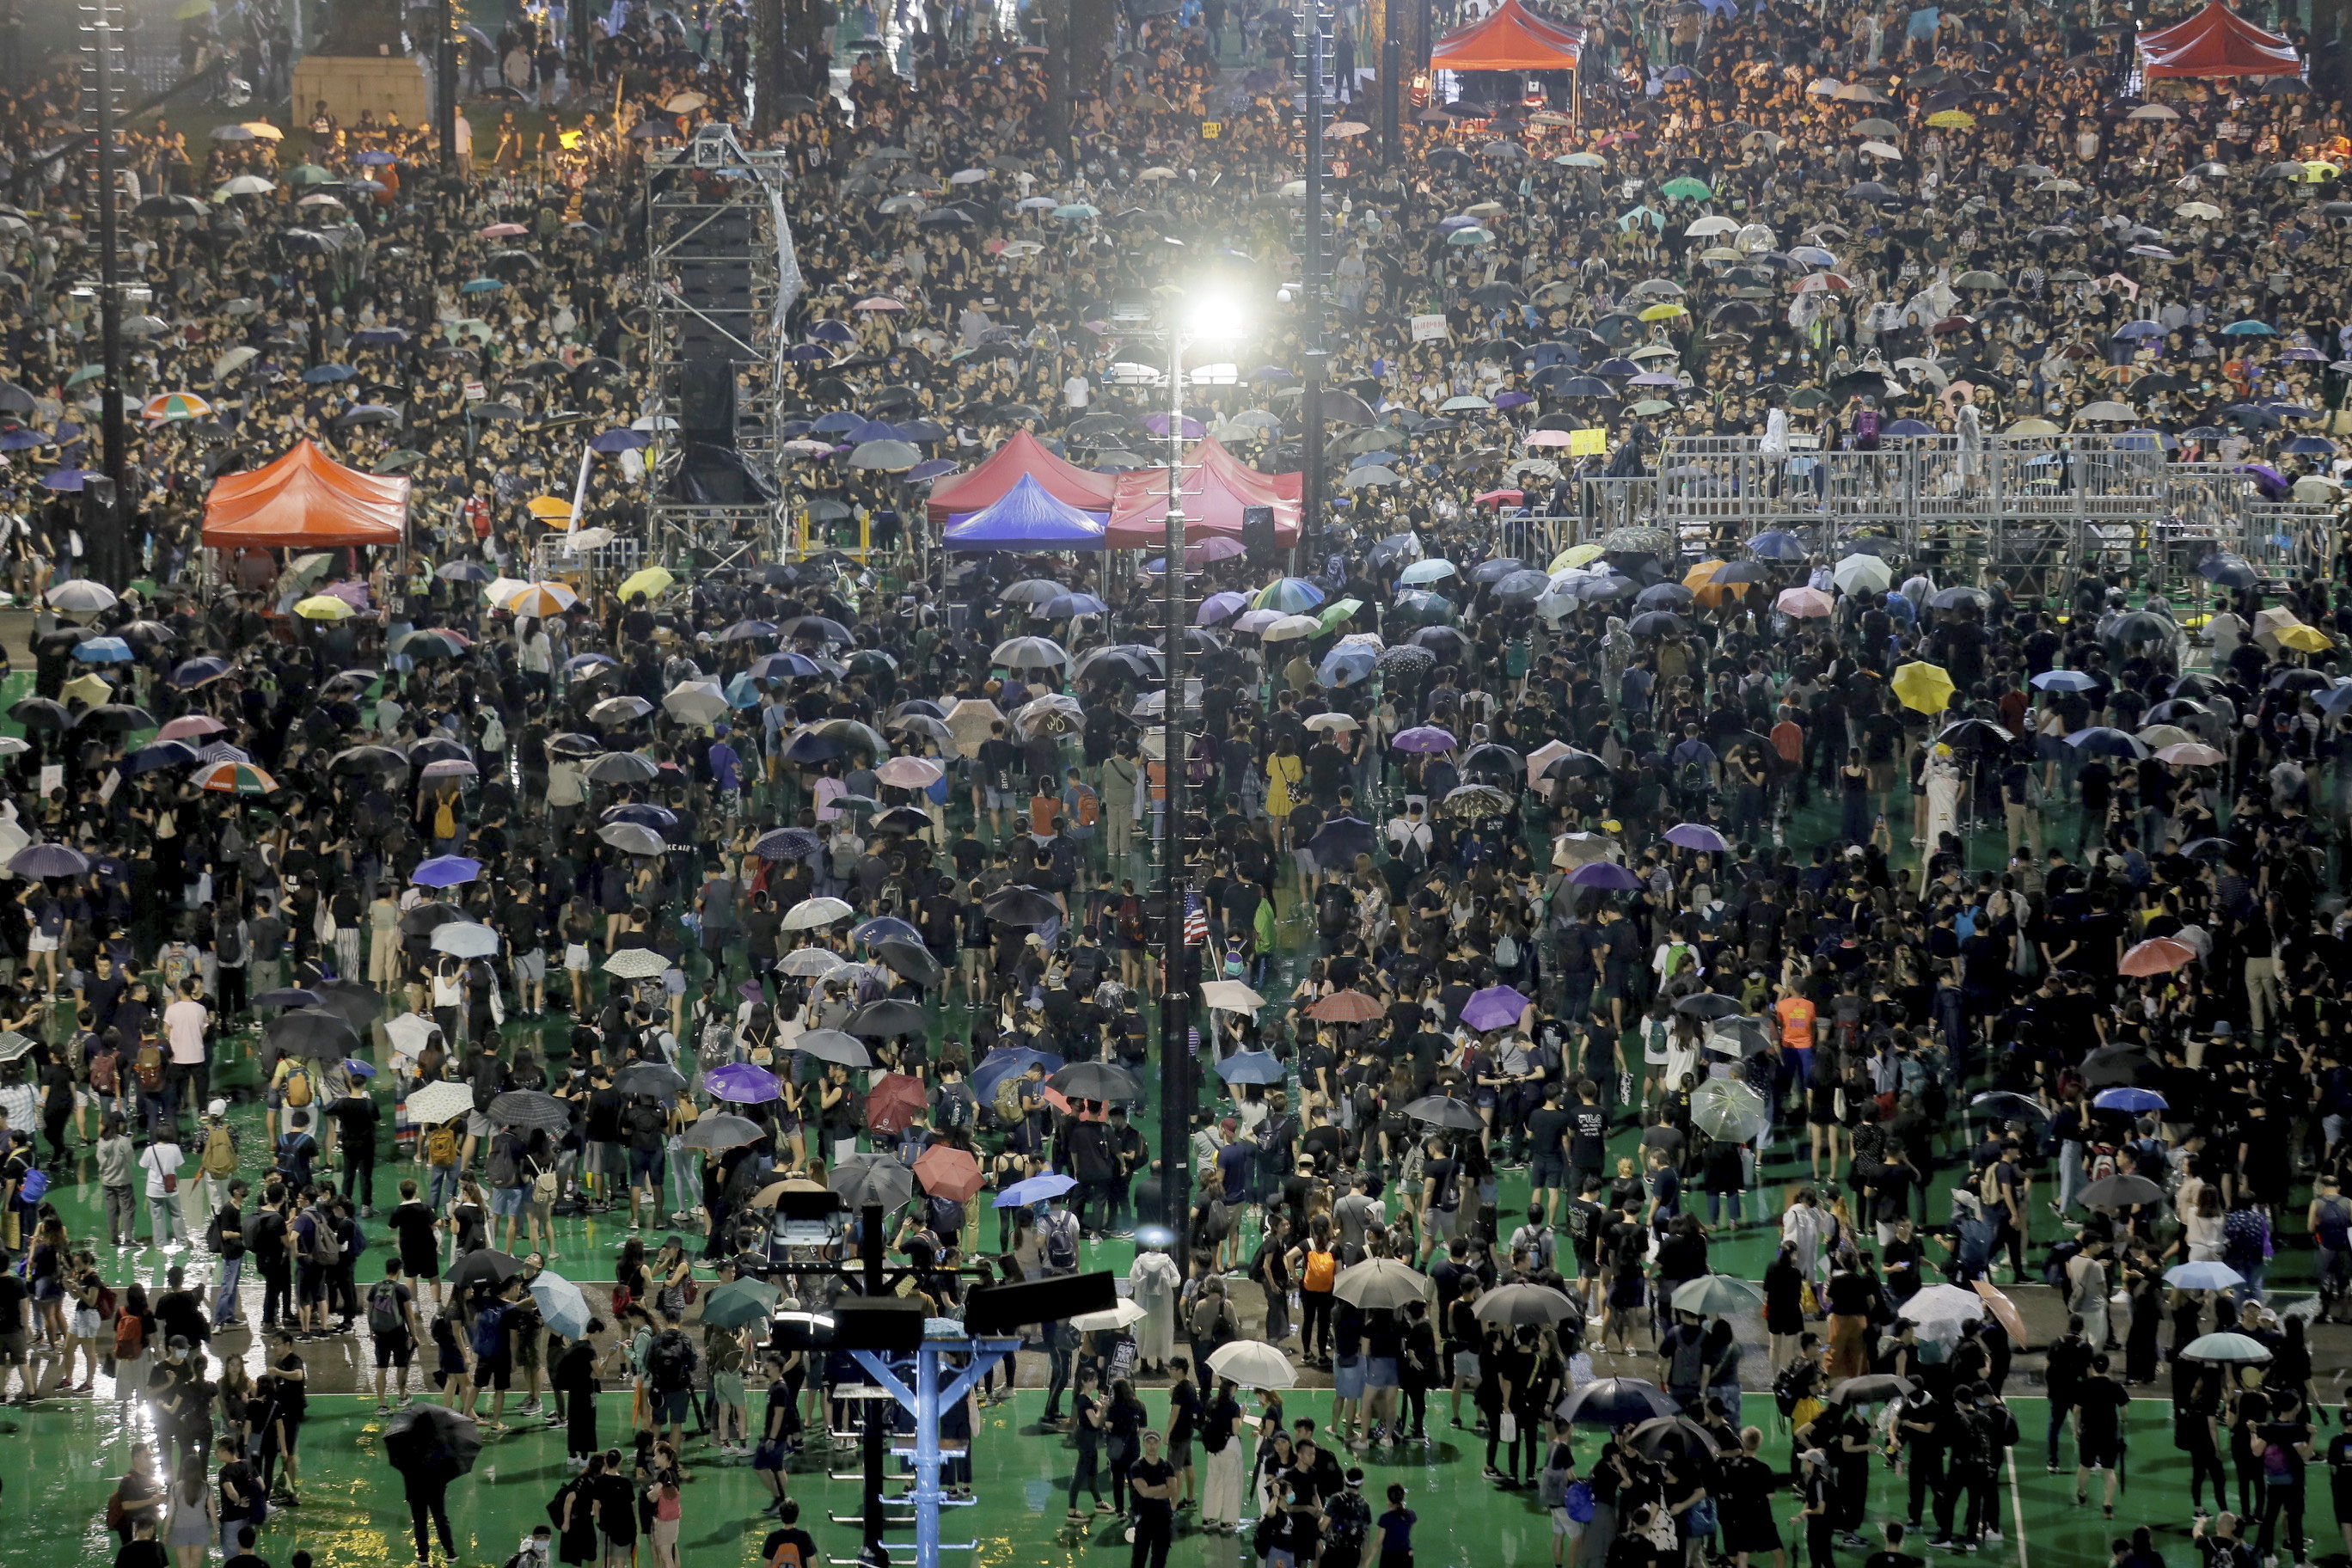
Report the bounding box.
[645,125,802,557]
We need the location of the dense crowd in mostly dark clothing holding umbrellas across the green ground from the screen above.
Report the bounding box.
[0,7,2352,1568]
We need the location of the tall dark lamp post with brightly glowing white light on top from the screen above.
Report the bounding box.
[1160,297,1240,1232]
